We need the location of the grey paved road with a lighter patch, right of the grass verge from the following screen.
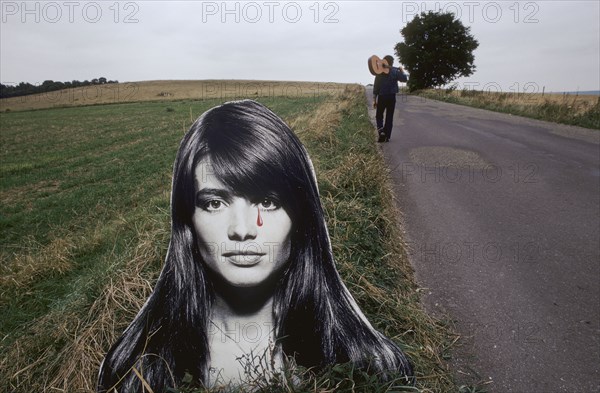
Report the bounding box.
[367,90,600,393]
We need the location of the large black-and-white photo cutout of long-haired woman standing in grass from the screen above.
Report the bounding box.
[97,100,413,393]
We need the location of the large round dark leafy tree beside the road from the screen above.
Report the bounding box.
[395,11,479,91]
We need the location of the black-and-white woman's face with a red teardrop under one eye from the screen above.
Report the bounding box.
[192,160,292,287]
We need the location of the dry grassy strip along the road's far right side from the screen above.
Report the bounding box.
[416,89,600,129]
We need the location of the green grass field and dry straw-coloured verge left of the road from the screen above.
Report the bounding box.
[0,81,458,393]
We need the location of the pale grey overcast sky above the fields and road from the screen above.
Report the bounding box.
[0,0,600,92]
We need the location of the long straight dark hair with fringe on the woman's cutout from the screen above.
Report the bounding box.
[98,100,412,392]
